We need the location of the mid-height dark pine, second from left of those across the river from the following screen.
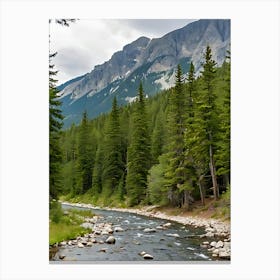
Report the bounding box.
[102,97,124,195]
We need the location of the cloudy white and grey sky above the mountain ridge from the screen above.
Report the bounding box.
[50,19,197,84]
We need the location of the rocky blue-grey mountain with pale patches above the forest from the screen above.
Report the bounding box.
[59,19,230,127]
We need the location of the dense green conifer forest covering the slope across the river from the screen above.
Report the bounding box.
[57,47,230,209]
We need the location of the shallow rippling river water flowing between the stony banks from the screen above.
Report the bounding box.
[50,205,217,263]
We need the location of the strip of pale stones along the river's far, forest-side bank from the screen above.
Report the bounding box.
[61,201,230,238]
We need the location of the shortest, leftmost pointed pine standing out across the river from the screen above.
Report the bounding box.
[78,112,93,193]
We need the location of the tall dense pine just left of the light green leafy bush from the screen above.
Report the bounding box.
[126,83,150,206]
